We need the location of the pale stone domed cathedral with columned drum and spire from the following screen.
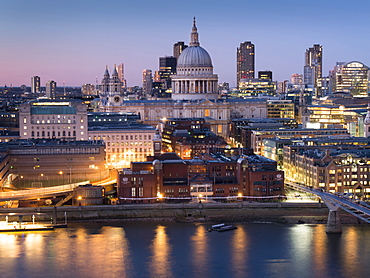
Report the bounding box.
[99,19,267,137]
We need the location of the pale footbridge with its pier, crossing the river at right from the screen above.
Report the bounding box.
[285,182,370,233]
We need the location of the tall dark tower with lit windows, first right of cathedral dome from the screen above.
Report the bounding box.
[236,42,254,85]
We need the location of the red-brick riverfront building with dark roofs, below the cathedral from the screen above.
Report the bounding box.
[118,149,284,203]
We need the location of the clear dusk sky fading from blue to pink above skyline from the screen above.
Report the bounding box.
[0,0,370,87]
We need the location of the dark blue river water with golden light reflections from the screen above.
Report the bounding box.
[0,222,370,278]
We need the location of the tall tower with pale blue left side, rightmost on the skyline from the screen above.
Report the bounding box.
[303,44,322,88]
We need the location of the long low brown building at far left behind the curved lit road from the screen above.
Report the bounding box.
[2,139,109,188]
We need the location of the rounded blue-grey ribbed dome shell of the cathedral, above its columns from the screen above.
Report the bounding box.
[177,46,212,67]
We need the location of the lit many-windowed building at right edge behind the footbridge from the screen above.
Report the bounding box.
[284,145,370,198]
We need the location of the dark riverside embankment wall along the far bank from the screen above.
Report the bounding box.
[0,202,360,224]
